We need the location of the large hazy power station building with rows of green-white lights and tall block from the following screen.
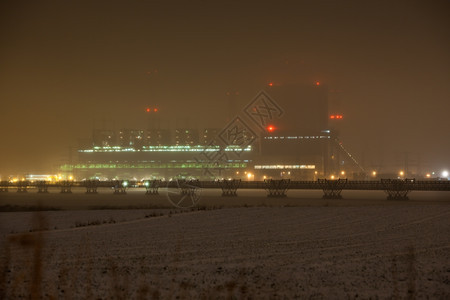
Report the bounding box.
[61,83,356,180]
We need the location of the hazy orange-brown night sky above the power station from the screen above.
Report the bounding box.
[0,0,450,175]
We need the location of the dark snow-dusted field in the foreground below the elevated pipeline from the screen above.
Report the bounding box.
[0,191,450,299]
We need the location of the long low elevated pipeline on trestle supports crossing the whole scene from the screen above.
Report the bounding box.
[0,179,450,200]
